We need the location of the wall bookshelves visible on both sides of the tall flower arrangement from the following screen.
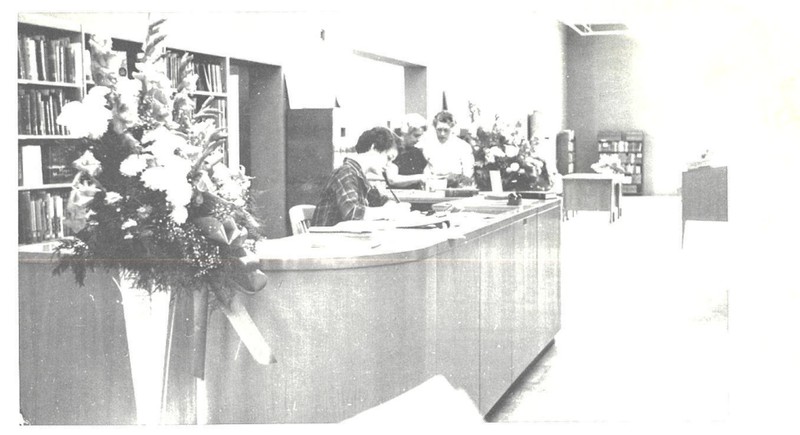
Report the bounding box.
[17,14,234,244]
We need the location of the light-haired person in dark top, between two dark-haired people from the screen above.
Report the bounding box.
[386,113,428,189]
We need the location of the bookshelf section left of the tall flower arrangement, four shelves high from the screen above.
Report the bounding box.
[17,19,85,243]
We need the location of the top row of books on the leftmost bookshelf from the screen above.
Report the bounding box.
[17,35,83,83]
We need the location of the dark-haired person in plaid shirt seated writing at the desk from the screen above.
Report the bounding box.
[311,127,408,226]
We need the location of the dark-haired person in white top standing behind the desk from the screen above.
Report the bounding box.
[421,111,475,185]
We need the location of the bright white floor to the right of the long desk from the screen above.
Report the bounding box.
[487,196,731,425]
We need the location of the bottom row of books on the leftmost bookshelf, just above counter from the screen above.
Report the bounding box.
[19,191,72,243]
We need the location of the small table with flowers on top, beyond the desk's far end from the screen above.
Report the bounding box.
[562,174,622,222]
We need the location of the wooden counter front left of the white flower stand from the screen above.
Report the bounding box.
[18,249,136,425]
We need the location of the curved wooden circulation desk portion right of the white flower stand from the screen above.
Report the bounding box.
[200,198,561,423]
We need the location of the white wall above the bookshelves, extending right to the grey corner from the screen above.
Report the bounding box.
[28,8,566,189]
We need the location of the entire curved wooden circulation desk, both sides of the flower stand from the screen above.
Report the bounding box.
[19,197,561,424]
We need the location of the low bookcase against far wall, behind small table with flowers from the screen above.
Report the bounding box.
[597,130,645,195]
